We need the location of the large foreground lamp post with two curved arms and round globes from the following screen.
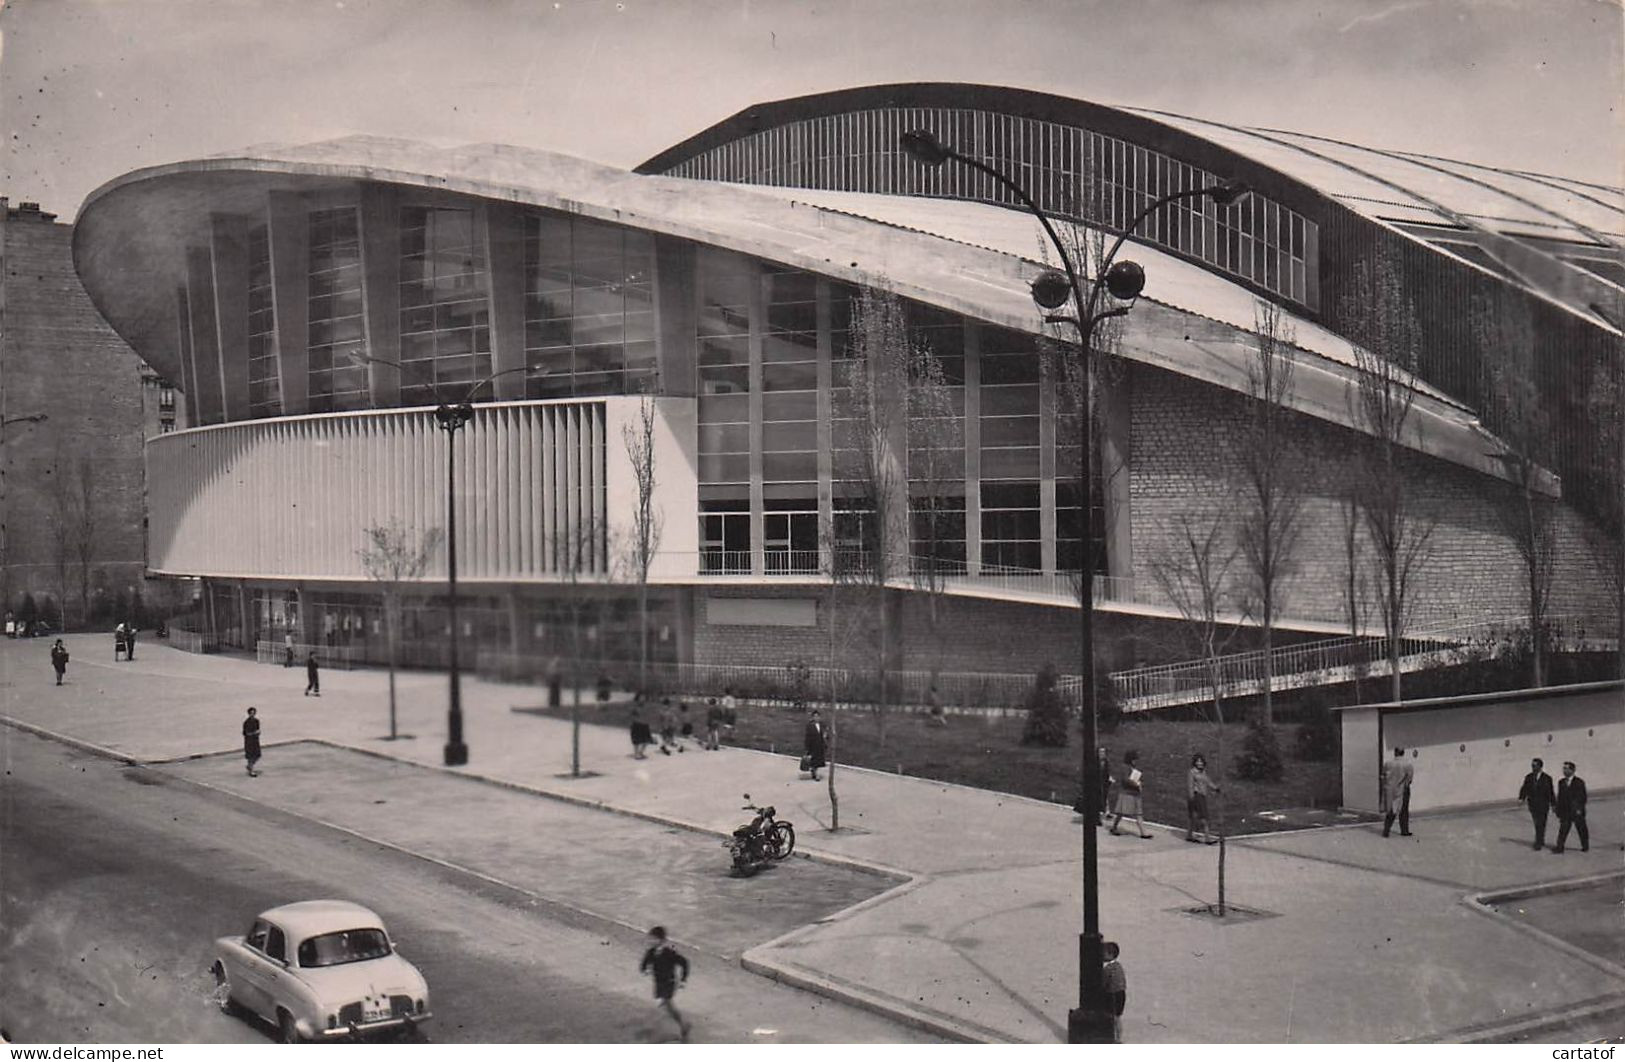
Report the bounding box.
[902,130,1246,1044]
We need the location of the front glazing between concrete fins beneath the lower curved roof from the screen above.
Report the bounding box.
[177,201,1118,587]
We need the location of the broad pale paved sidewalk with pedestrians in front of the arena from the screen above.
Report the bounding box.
[0,635,1625,1043]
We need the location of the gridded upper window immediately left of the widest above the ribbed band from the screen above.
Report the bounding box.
[400,206,491,406]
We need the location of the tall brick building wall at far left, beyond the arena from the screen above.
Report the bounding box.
[0,208,154,620]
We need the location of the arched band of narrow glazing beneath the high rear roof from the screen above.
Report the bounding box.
[668,107,1320,309]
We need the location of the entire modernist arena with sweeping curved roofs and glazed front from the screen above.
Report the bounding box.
[75,84,1625,691]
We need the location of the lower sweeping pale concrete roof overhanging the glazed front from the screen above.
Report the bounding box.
[73,136,1534,493]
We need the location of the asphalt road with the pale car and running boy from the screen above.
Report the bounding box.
[0,727,925,1043]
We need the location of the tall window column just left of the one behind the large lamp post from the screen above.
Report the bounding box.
[980,328,1043,570]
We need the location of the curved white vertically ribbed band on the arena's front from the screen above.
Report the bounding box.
[146,396,697,581]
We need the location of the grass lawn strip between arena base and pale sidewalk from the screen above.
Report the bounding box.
[546,700,1341,835]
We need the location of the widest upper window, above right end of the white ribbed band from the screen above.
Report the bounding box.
[525,214,657,398]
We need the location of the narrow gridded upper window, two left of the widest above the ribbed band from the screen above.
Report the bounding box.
[309,206,371,412]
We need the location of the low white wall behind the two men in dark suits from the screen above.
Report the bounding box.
[1341,682,1625,812]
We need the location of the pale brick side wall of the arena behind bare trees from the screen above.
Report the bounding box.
[1129,365,1612,627]
